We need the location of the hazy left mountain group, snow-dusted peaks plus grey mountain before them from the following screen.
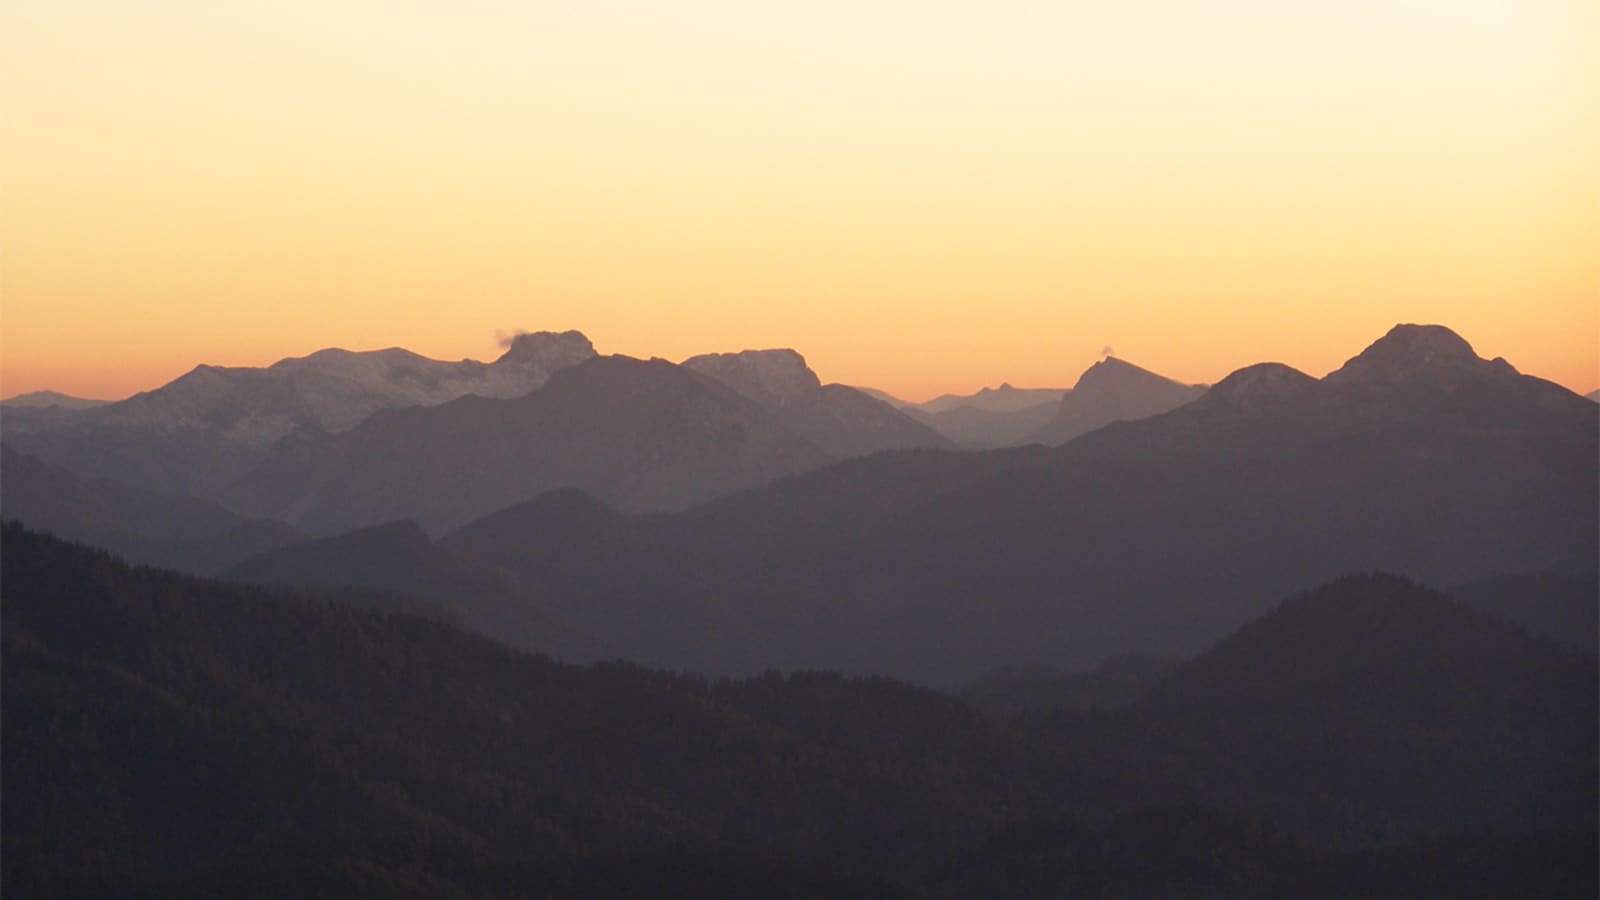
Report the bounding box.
[5,331,950,533]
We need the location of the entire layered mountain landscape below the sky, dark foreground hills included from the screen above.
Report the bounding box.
[0,317,1600,898]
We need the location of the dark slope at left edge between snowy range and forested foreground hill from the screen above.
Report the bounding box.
[0,444,302,575]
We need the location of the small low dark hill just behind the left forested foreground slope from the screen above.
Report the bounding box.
[221,522,585,660]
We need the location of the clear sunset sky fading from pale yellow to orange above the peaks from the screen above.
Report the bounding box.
[0,0,1600,399]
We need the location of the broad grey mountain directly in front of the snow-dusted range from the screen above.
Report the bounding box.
[227,350,830,533]
